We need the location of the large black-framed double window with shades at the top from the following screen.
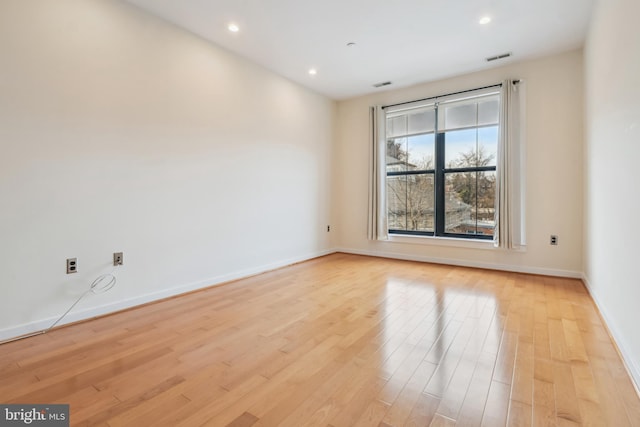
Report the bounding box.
[385,88,500,239]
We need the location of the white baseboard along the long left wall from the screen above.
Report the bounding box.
[0,249,335,343]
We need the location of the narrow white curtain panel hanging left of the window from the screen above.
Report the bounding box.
[367,107,389,240]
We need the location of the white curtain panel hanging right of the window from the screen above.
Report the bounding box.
[495,80,526,249]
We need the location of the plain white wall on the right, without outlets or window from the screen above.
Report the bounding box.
[584,0,640,384]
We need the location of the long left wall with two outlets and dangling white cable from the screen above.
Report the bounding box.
[0,0,335,339]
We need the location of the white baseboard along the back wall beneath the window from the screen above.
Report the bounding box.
[336,248,582,279]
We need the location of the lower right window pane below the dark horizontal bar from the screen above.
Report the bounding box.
[445,172,496,236]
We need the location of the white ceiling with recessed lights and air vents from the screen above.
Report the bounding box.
[127,0,595,99]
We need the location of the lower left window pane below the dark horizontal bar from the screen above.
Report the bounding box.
[387,174,434,232]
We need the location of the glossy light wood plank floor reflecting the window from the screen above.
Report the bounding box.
[0,254,640,427]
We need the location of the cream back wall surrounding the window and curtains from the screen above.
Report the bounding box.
[335,51,583,277]
